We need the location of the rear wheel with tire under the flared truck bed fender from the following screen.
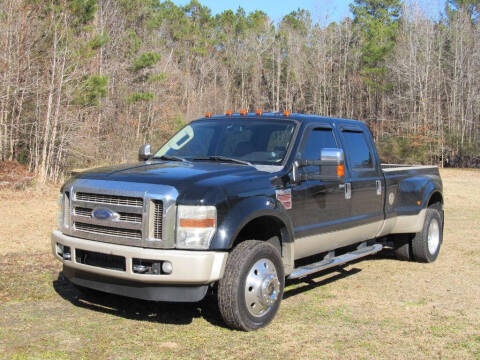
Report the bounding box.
[412,207,443,263]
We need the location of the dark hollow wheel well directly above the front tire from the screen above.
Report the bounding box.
[232,216,286,253]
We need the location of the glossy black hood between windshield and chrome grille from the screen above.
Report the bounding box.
[72,161,275,204]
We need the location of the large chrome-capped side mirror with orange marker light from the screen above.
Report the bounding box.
[293,148,345,184]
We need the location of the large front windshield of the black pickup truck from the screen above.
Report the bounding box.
[154,119,295,165]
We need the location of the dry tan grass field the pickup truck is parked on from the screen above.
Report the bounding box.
[0,170,480,359]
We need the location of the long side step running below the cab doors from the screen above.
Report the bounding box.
[288,244,383,279]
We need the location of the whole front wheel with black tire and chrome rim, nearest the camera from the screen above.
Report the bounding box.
[217,240,285,331]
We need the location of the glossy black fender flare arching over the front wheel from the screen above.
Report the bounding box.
[210,196,293,250]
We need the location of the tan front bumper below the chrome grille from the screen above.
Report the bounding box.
[52,230,228,301]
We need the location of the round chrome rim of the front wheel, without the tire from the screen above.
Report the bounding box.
[245,259,280,317]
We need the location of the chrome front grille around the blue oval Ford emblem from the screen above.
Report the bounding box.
[64,179,178,249]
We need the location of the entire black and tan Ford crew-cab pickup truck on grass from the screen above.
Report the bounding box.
[52,112,444,331]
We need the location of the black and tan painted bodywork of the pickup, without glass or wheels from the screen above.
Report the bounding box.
[55,113,443,296]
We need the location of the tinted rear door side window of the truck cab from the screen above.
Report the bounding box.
[343,131,373,170]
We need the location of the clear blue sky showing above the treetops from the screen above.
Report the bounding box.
[173,0,445,25]
